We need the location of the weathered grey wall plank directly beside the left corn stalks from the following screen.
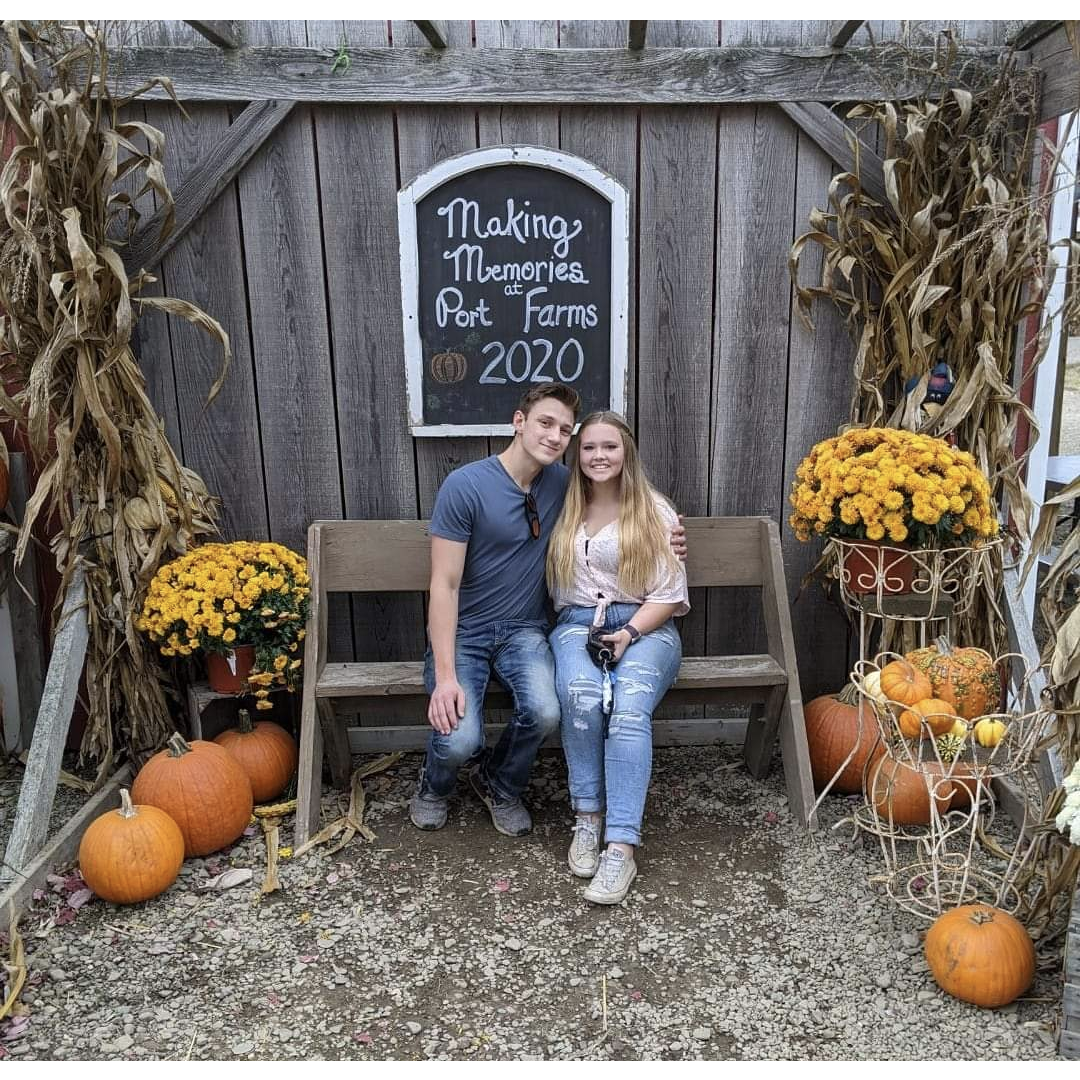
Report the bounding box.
[139,23,269,540]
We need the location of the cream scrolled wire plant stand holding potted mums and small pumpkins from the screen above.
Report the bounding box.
[814,538,1054,920]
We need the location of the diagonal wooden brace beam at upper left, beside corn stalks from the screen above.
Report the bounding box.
[123,100,296,273]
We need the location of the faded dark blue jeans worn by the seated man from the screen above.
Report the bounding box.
[422,622,559,801]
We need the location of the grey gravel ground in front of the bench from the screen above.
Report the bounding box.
[0,746,1062,1061]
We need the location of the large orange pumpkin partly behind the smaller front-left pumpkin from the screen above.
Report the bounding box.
[132,734,253,855]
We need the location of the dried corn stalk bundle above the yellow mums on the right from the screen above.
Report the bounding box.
[788,35,1075,656]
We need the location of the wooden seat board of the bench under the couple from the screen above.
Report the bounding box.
[315,654,787,698]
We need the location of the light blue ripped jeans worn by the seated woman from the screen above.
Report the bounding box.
[551,604,683,847]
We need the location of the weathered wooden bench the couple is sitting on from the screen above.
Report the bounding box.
[295,517,814,845]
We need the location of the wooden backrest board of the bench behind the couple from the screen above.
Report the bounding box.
[308,517,774,593]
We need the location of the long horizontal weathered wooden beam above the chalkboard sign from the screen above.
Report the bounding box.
[101,45,1010,105]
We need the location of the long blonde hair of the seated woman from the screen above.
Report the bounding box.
[548,411,677,596]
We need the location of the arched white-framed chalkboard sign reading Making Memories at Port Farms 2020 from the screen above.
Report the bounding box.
[397,147,629,435]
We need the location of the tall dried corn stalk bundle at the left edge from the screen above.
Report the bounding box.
[0,22,230,781]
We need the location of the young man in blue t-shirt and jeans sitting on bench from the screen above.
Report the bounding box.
[409,382,581,836]
